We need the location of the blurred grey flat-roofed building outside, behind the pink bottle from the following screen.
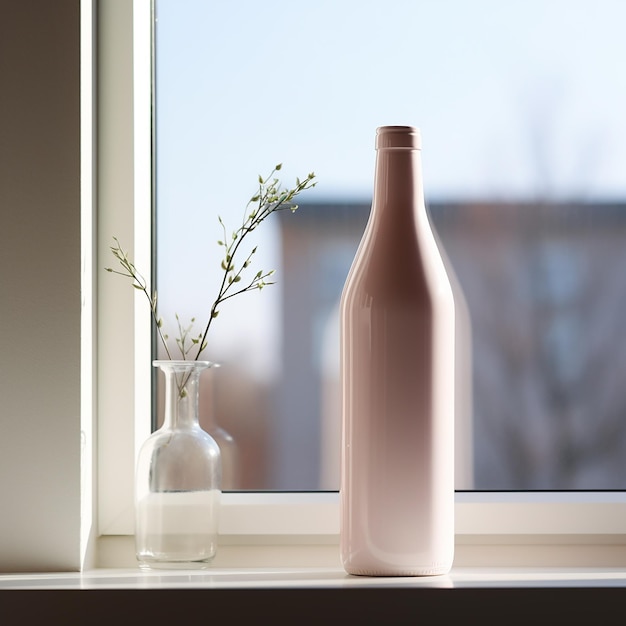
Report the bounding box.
[271,197,626,490]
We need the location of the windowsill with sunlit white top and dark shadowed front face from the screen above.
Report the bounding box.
[0,546,626,626]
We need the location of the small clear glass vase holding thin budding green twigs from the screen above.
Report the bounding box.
[135,360,222,568]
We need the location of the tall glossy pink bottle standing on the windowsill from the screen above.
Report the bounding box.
[340,126,455,576]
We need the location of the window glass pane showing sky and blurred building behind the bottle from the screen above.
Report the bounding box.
[156,0,626,490]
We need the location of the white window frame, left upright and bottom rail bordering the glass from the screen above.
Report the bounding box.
[95,0,626,560]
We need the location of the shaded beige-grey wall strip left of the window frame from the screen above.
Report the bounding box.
[0,0,81,572]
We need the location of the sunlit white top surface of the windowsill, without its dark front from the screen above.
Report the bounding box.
[0,566,626,591]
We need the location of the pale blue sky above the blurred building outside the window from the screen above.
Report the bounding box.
[157,0,626,365]
